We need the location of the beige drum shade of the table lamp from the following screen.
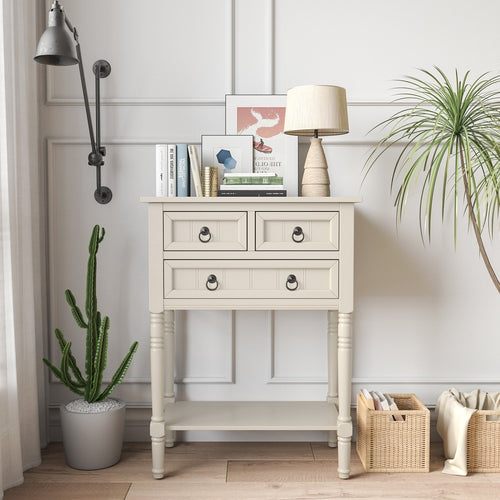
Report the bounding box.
[284,85,349,137]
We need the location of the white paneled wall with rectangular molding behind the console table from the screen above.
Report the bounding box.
[38,0,500,439]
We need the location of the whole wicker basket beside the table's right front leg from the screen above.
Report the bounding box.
[356,394,430,472]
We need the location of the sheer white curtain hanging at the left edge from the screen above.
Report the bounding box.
[0,0,44,498]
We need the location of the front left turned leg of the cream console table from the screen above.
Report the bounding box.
[150,312,165,479]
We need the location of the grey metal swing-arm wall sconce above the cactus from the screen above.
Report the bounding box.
[34,0,113,204]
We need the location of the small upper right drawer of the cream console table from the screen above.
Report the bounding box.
[255,212,339,251]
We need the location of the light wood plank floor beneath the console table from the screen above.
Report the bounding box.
[5,443,500,500]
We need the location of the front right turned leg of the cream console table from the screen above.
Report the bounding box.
[337,312,352,479]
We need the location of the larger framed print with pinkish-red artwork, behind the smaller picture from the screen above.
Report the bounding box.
[226,95,299,196]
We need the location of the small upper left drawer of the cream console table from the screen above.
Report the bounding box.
[163,211,247,251]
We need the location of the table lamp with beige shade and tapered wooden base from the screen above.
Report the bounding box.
[284,85,349,196]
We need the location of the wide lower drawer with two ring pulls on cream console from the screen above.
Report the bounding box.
[164,260,339,298]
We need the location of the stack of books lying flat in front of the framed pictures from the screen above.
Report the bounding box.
[217,172,286,196]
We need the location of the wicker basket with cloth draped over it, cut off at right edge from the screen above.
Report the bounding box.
[467,410,500,472]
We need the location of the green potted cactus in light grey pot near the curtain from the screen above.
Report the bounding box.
[43,225,138,470]
